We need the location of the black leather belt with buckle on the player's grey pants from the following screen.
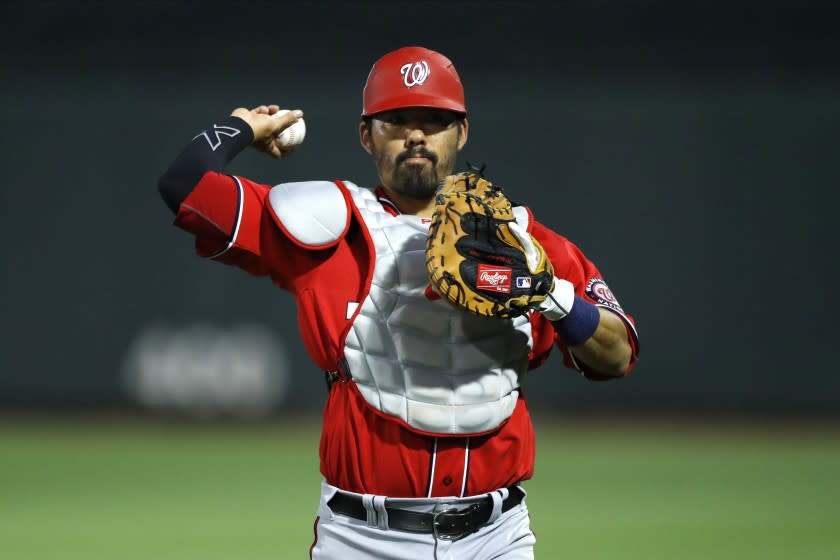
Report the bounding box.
[327,486,525,540]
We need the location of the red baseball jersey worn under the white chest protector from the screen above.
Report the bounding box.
[175,171,637,497]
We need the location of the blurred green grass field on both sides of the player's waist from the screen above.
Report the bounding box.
[0,418,840,560]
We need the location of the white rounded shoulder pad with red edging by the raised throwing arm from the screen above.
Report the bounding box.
[268,181,350,249]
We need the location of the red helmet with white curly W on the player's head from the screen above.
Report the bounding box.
[362,47,467,117]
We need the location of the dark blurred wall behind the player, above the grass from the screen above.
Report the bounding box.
[0,0,840,412]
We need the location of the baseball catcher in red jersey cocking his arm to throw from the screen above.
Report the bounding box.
[159,47,638,560]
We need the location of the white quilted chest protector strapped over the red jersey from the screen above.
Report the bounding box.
[272,183,532,434]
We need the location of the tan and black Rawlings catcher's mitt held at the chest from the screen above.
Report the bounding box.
[426,172,554,318]
